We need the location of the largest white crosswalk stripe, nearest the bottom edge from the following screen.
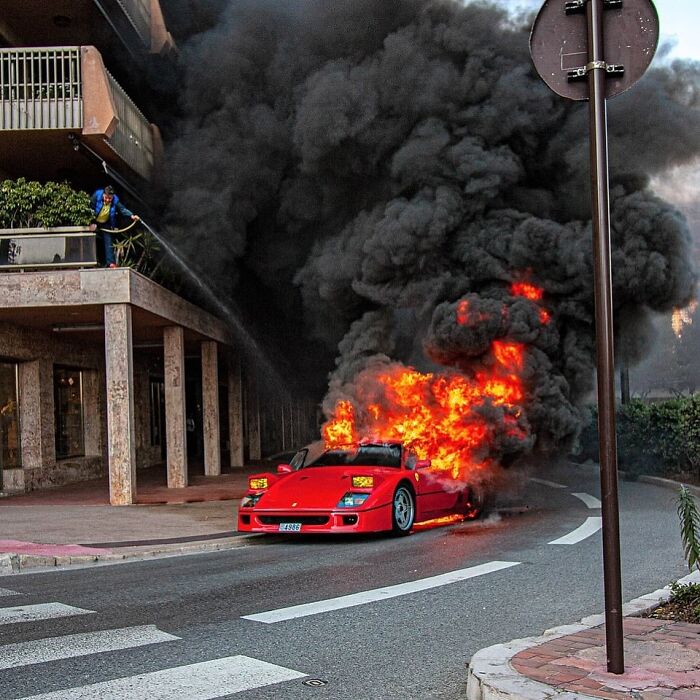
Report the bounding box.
[25,656,307,700]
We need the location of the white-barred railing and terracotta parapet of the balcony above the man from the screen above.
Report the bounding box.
[0,45,154,180]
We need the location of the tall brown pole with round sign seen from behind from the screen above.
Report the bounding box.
[530,0,659,674]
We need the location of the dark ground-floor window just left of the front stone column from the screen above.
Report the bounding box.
[54,367,85,459]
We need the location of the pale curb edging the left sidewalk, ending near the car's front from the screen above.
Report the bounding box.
[0,535,255,576]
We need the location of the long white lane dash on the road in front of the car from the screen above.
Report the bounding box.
[243,561,520,625]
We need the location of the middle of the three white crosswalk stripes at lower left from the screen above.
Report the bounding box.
[0,625,180,669]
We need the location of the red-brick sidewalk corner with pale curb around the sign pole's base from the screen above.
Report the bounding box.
[467,571,700,700]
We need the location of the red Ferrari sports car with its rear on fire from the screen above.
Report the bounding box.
[238,442,481,535]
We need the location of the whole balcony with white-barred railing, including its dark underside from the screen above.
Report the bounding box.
[0,46,159,181]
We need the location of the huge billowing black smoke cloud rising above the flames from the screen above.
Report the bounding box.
[168,0,700,460]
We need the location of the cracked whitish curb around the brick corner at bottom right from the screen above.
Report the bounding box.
[466,568,700,700]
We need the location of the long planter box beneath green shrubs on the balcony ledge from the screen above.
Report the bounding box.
[0,226,97,271]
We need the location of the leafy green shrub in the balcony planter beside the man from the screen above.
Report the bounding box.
[0,177,94,228]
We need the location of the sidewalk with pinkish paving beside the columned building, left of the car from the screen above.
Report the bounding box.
[0,465,270,574]
